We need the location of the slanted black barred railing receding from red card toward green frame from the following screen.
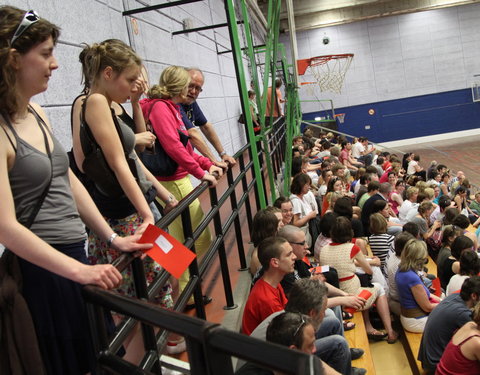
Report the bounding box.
[81,116,285,373]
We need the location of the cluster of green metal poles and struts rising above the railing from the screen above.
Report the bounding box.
[231,0,301,203]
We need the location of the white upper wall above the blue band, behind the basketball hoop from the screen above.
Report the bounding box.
[282,4,480,112]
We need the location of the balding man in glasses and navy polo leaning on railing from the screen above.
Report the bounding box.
[180,68,235,168]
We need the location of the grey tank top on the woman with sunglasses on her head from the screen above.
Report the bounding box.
[7,111,86,244]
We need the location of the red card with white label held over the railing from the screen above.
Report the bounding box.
[138,224,196,279]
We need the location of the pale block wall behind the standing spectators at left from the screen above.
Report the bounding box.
[4,0,246,154]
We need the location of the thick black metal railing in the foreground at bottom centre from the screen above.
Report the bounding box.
[83,286,322,375]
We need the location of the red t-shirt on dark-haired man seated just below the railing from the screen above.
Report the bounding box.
[242,278,288,335]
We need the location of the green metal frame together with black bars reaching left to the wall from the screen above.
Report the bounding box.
[123,0,301,208]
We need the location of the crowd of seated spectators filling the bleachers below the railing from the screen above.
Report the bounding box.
[243,132,480,374]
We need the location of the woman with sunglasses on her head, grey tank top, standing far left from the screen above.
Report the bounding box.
[0,6,151,375]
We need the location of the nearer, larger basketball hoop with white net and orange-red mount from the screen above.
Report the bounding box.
[297,53,353,94]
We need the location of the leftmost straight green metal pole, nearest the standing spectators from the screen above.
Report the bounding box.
[225,0,268,208]
